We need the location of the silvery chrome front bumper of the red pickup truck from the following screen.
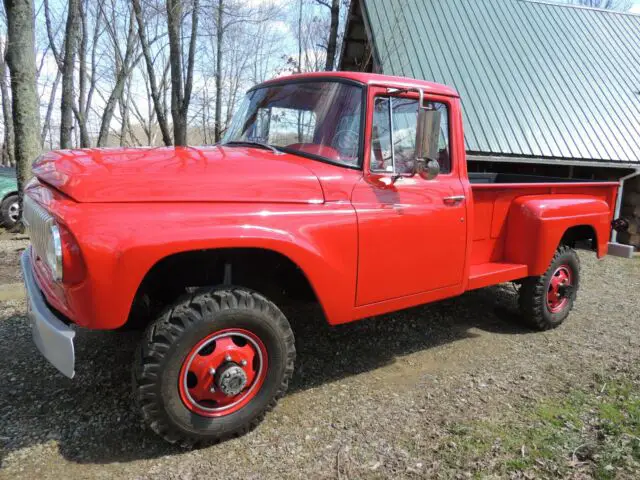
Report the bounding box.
[20,248,76,378]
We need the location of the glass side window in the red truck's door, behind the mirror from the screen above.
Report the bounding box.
[371,97,451,174]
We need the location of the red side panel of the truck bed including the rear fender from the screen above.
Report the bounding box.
[471,182,618,275]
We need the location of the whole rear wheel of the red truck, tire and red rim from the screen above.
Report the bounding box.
[519,245,580,330]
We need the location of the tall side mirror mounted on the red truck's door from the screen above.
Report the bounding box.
[416,95,441,180]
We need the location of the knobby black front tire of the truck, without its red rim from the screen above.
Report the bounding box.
[133,287,296,447]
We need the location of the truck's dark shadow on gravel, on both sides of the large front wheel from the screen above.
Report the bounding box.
[0,285,529,467]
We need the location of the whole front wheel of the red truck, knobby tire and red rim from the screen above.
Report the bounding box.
[133,288,295,445]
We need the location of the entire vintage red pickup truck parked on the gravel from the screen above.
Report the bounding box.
[22,73,618,443]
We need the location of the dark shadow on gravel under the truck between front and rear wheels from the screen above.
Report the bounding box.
[285,285,531,392]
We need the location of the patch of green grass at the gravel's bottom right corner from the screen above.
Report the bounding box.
[438,375,640,479]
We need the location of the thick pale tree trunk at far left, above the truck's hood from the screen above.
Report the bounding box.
[4,0,41,212]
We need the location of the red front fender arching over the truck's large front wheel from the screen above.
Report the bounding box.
[74,203,357,329]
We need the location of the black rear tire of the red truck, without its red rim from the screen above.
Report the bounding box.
[519,245,580,330]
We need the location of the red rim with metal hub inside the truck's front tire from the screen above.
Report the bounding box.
[178,328,268,417]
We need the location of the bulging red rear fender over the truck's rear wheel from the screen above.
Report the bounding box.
[505,195,611,275]
